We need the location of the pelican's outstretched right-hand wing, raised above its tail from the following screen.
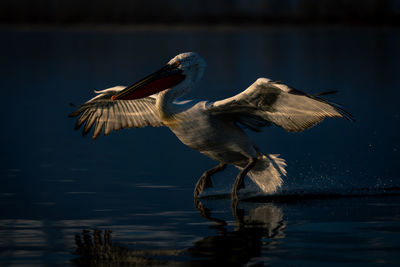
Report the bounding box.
[210,78,352,132]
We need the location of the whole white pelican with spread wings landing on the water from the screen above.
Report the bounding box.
[69,52,352,200]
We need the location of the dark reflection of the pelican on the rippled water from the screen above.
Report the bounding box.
[73,201,286,266]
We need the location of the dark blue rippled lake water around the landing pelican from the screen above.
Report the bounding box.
[0,27,400,266]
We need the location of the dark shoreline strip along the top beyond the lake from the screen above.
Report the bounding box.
[0,0,400,25]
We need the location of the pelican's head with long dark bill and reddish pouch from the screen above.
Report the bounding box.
[111,52,207,100]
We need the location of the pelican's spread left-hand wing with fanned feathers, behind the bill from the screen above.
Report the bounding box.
[69,86,163,139]
